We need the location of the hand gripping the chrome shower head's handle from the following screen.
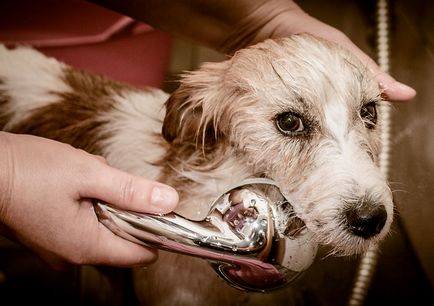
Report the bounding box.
[0,132,178,267]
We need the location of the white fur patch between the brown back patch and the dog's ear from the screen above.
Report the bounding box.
[102,89,168,180]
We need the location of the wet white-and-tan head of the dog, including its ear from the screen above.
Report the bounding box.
[163,35,393,255]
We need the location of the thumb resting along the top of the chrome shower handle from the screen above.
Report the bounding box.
[80,159,178,213]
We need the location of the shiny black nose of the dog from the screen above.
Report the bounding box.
[346,203,387,239]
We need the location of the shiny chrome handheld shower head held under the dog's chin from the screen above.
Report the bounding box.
[95,178,317,292]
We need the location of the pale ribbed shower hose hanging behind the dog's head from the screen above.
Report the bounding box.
[348,0,391,306]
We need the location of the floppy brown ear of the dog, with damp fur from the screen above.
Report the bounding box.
[163,61,229,148]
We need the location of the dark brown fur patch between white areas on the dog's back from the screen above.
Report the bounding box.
[10,68,125,154]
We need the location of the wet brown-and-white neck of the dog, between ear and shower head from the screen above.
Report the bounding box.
[158,141,253,220]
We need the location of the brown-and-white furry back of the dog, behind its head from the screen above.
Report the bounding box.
[0,46,167,179]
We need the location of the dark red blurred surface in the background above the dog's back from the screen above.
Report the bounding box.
[0,0,171,87]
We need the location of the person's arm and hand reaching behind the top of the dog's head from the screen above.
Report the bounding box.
[92,0,416,101]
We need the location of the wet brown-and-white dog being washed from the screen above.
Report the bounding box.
[0,34,393,305]
